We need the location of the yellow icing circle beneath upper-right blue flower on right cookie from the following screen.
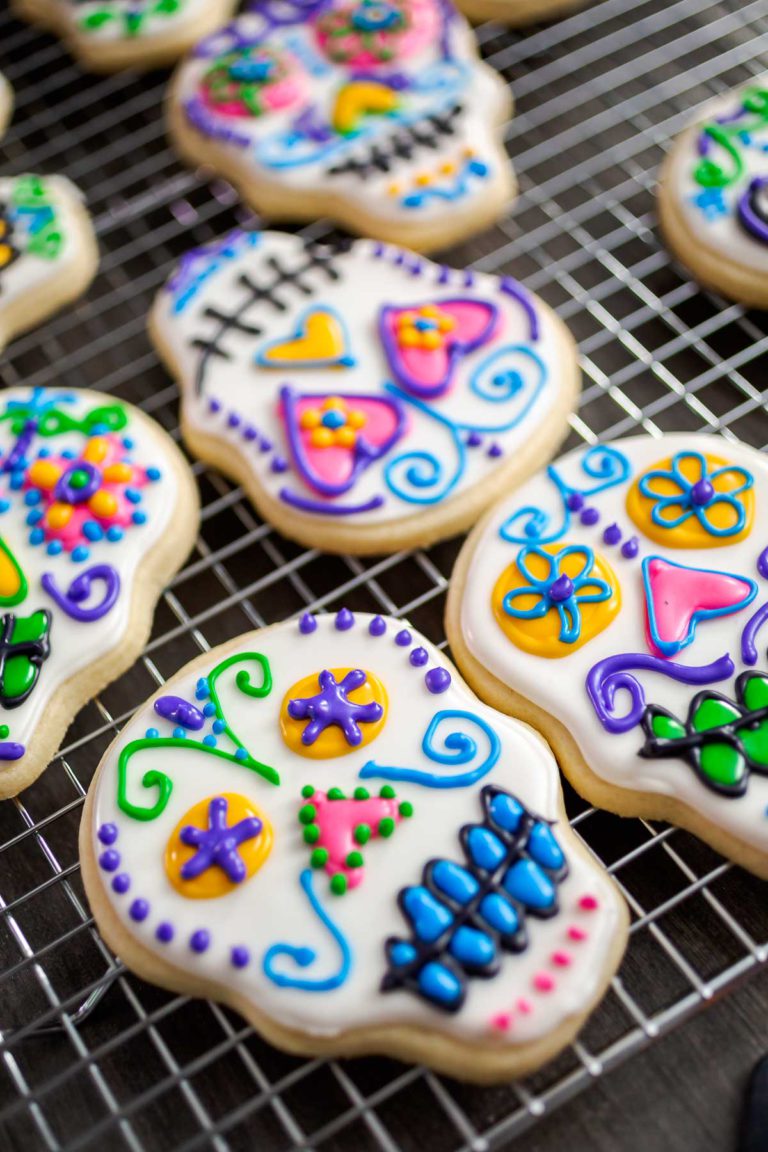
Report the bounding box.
[626,452,754,548]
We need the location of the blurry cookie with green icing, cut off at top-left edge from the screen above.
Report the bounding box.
[12,0,237,71]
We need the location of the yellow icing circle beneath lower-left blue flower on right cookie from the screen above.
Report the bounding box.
[491,540,622,659]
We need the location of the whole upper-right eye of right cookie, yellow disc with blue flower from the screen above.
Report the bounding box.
[626,452,754,548]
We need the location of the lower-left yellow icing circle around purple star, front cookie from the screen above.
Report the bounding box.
[165,793,274,900]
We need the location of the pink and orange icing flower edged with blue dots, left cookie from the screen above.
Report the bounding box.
[24,434,160,559]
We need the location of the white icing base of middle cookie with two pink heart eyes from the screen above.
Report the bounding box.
[152,232,573,532]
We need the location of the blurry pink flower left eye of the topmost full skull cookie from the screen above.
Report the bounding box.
[200,44,307,116]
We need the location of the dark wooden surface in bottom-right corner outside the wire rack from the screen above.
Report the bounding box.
[507,971,768,1152]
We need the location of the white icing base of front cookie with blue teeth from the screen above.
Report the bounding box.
[90,614,622,1045]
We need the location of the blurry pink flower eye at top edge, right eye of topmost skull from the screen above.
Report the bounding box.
[315,0,440,68]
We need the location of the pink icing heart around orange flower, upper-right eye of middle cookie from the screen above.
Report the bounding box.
[380,300,499,397]
